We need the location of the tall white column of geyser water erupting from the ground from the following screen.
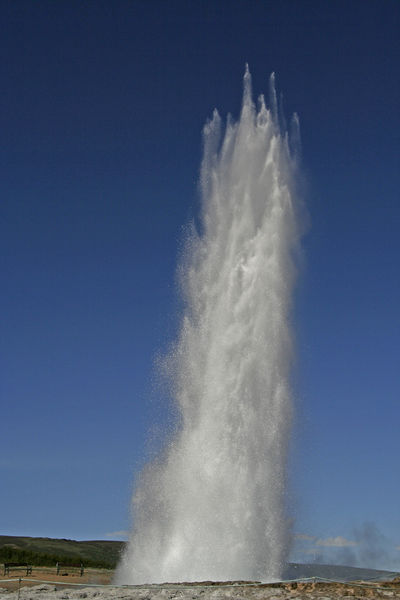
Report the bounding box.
[117,69,300,583]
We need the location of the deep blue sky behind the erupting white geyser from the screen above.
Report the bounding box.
[0,0,400,569]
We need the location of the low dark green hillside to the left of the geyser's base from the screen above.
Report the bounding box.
[0,535,125,569]
